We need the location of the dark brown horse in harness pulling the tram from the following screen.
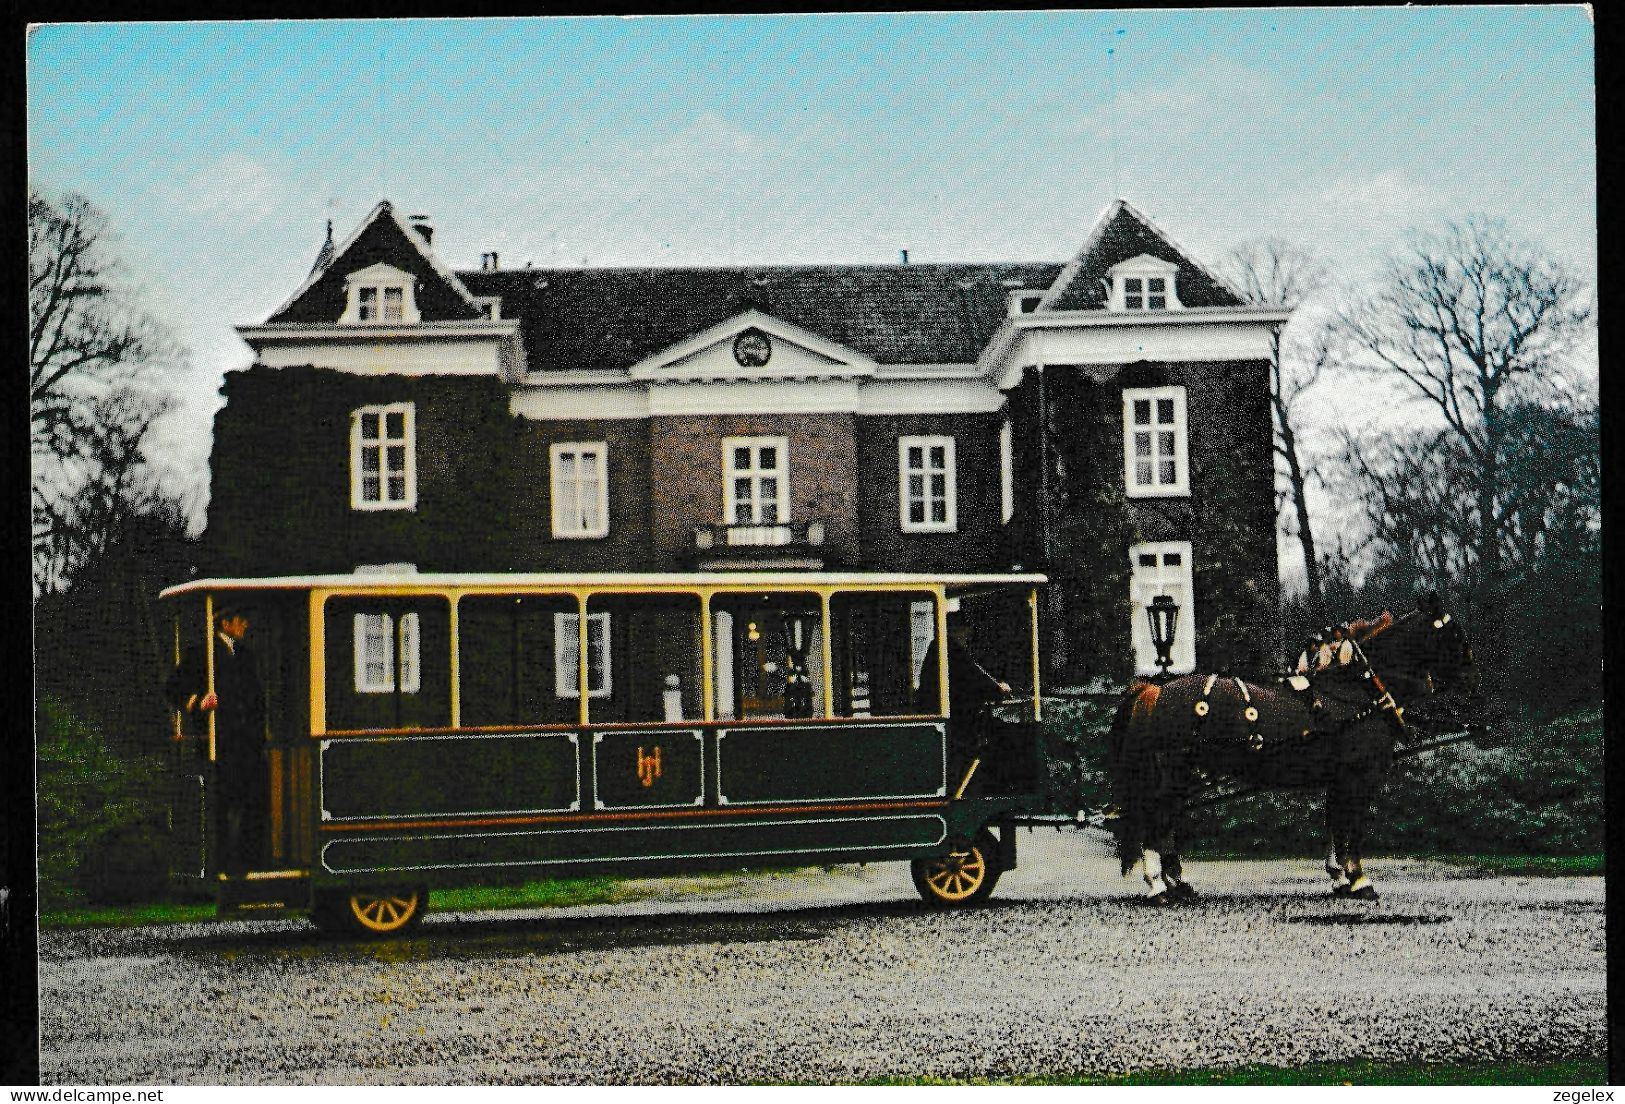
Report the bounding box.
[1107,595,1477,904]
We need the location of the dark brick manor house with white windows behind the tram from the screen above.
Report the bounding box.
[200,200,1285,686]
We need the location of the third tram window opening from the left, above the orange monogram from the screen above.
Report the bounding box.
[591,593,704,725]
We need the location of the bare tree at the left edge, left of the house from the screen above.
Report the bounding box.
[28,192,177,589]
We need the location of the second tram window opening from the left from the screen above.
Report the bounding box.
[457,595,578,727]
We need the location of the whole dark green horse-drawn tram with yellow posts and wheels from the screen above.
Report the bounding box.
[164,569,1045,933]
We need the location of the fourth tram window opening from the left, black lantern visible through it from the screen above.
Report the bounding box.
[712,592,824,719]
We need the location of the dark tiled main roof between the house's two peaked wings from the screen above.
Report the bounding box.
[461,263,1061,371]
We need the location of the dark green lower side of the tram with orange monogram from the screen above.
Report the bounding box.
[320,722,949,881]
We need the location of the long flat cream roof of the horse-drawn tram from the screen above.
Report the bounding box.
[159,571,1048,598]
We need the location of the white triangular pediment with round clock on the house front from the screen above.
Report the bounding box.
[629,311,874,384]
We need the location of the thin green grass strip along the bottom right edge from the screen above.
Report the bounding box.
[865,1058,1609,1086]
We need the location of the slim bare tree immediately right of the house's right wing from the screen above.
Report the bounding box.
[1224,237,1333,613]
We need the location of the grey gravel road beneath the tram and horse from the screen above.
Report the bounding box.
[31,829,1606,1084]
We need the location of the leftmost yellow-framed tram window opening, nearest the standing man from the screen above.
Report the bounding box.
[325,597,452,730]
